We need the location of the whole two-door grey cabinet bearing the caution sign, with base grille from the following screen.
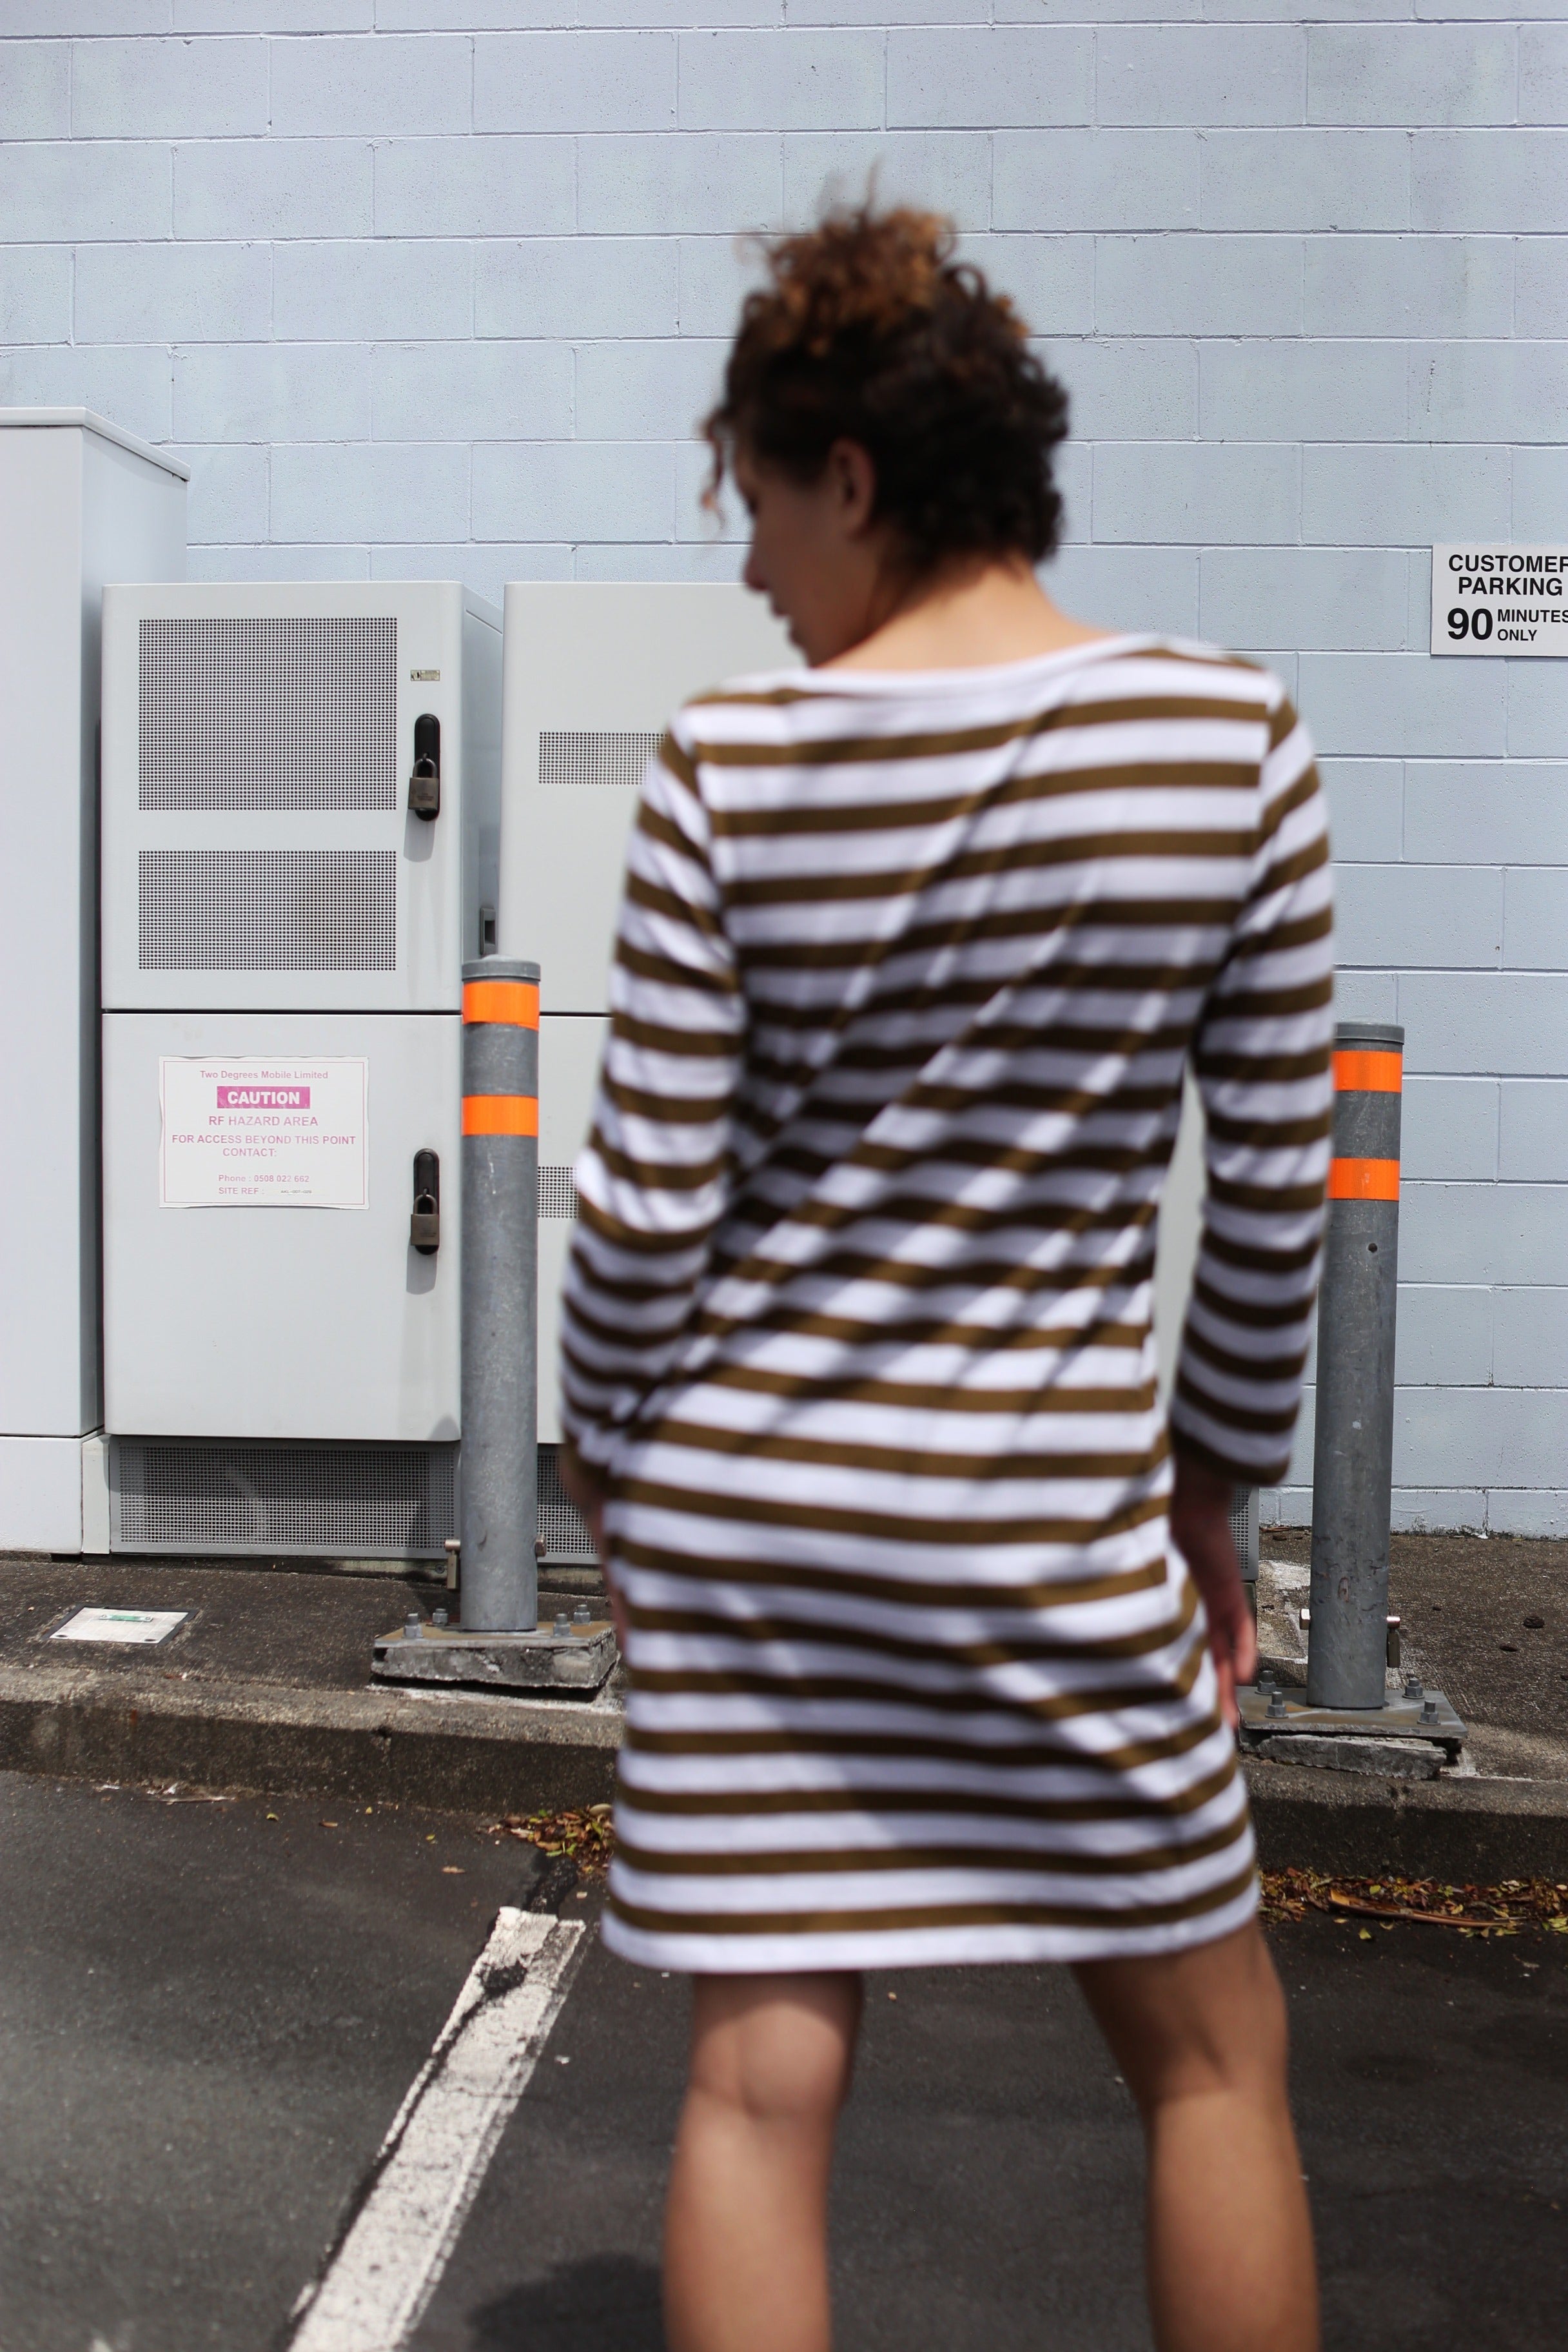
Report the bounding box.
[103,583,501,1557]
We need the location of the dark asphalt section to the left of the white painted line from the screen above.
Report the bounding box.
[0,1774,552,2352]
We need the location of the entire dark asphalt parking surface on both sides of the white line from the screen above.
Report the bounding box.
[0,1776,1568,2352]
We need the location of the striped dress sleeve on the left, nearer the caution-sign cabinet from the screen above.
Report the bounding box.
[562,718,745,1470]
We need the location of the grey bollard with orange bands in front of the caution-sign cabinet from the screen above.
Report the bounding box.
[461,955,538,1632]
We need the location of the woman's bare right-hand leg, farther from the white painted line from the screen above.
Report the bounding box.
[1074,1924,1319,2352]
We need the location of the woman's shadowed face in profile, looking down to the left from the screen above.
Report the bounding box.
[734,442,884,668]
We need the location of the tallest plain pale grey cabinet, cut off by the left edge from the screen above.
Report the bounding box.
[0,409,186,1553]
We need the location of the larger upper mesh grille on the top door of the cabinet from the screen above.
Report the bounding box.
[139,614,397,809]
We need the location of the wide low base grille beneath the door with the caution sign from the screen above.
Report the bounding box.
[113,1437,458,1560]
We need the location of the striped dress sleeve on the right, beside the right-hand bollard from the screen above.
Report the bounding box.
[1171,694,1333,1487]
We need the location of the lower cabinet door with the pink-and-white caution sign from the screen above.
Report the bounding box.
[103,1014,463,1440]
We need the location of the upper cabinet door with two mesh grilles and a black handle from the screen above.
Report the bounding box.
[101,581,463,1014]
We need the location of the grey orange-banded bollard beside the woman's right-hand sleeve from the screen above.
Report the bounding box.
[1307,1021,1406,1707]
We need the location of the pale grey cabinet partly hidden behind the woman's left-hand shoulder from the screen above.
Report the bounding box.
[501,581,799,1560]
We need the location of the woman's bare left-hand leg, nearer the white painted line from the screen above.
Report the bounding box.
[665,1975,860,2352]
